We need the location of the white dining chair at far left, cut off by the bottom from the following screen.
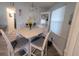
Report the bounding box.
[0,30,27,56]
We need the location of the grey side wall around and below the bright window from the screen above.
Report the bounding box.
[49,3,75,55]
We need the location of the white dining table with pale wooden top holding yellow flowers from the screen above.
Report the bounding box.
[17,27,47,55]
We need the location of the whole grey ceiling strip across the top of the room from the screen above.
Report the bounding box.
[0,2,57,9]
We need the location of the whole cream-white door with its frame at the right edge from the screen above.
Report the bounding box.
[64,3,79,56]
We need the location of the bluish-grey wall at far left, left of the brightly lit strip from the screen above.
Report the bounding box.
[0,2,9,27]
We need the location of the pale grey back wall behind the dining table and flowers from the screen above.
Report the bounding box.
[15,2,43,29]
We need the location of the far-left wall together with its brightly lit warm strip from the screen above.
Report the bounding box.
[0,2,14,32]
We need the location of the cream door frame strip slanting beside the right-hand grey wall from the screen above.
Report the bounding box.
[64,3,79,56]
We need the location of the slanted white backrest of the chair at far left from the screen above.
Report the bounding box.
[0,29,14,56]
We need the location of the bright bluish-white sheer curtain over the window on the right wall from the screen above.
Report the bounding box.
[50,6,66,35]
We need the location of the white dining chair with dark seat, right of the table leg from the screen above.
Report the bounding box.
[30,32,50,56]
